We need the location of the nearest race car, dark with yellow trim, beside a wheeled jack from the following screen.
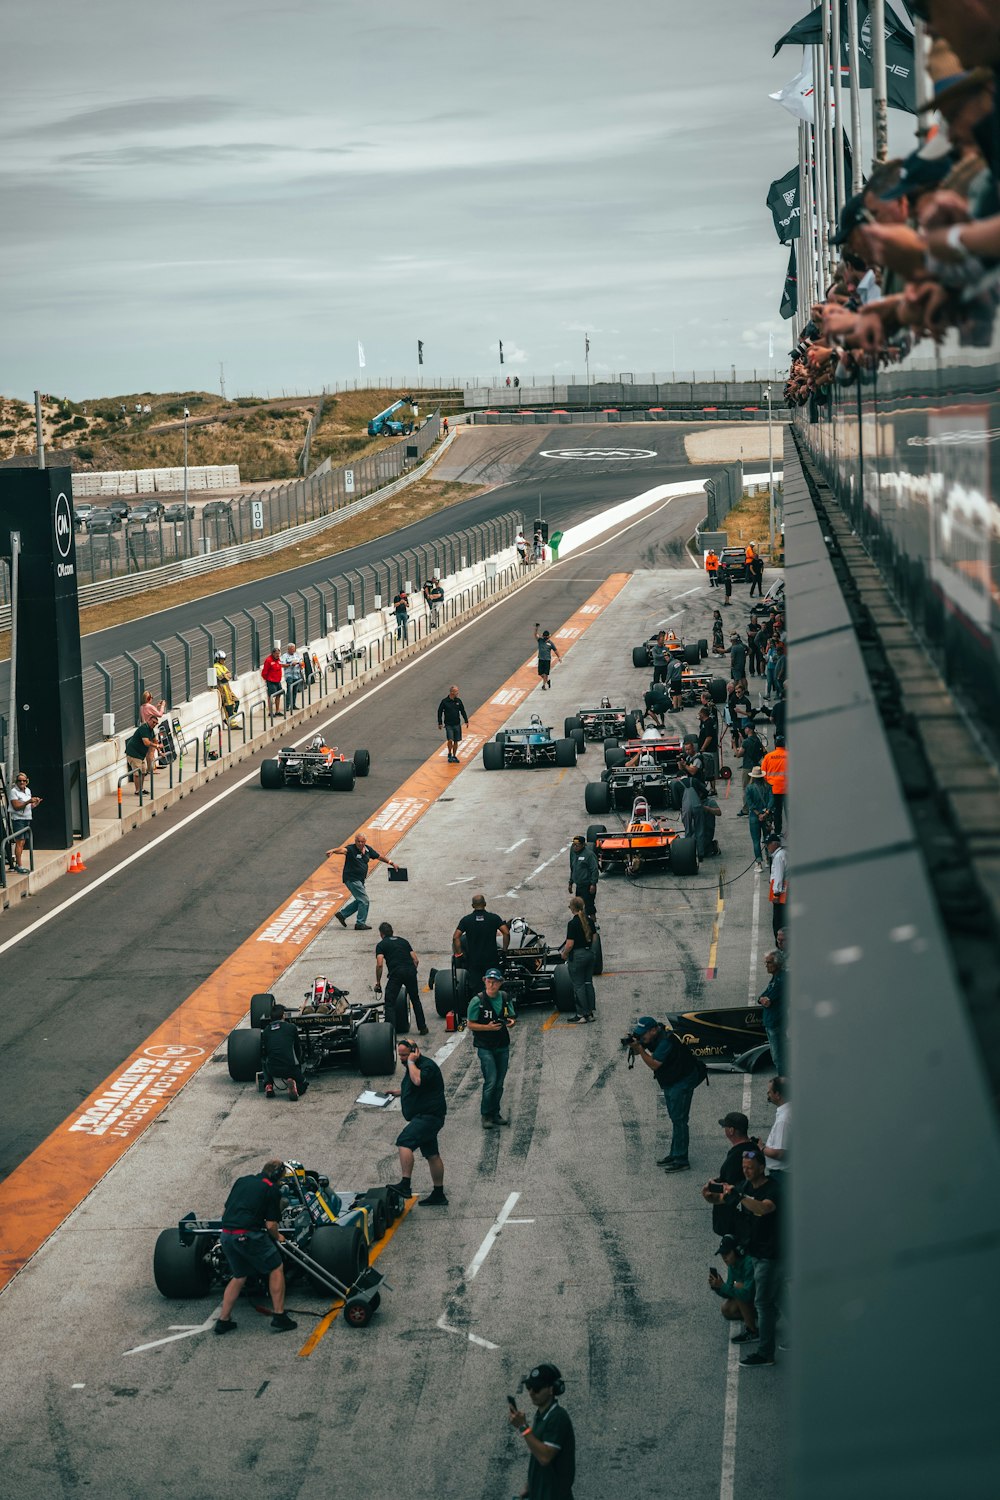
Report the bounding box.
[153,1161,405,1328]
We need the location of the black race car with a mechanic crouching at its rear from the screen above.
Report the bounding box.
[226,975,396,1089]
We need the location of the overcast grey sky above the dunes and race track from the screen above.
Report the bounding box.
[0,0,905,398]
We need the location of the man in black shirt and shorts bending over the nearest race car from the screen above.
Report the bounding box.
[216,1160,298,1334]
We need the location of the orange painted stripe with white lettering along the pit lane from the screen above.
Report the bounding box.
[0,573,631,1292]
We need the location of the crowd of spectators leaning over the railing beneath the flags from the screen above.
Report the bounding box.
[786,0,1000,417]
